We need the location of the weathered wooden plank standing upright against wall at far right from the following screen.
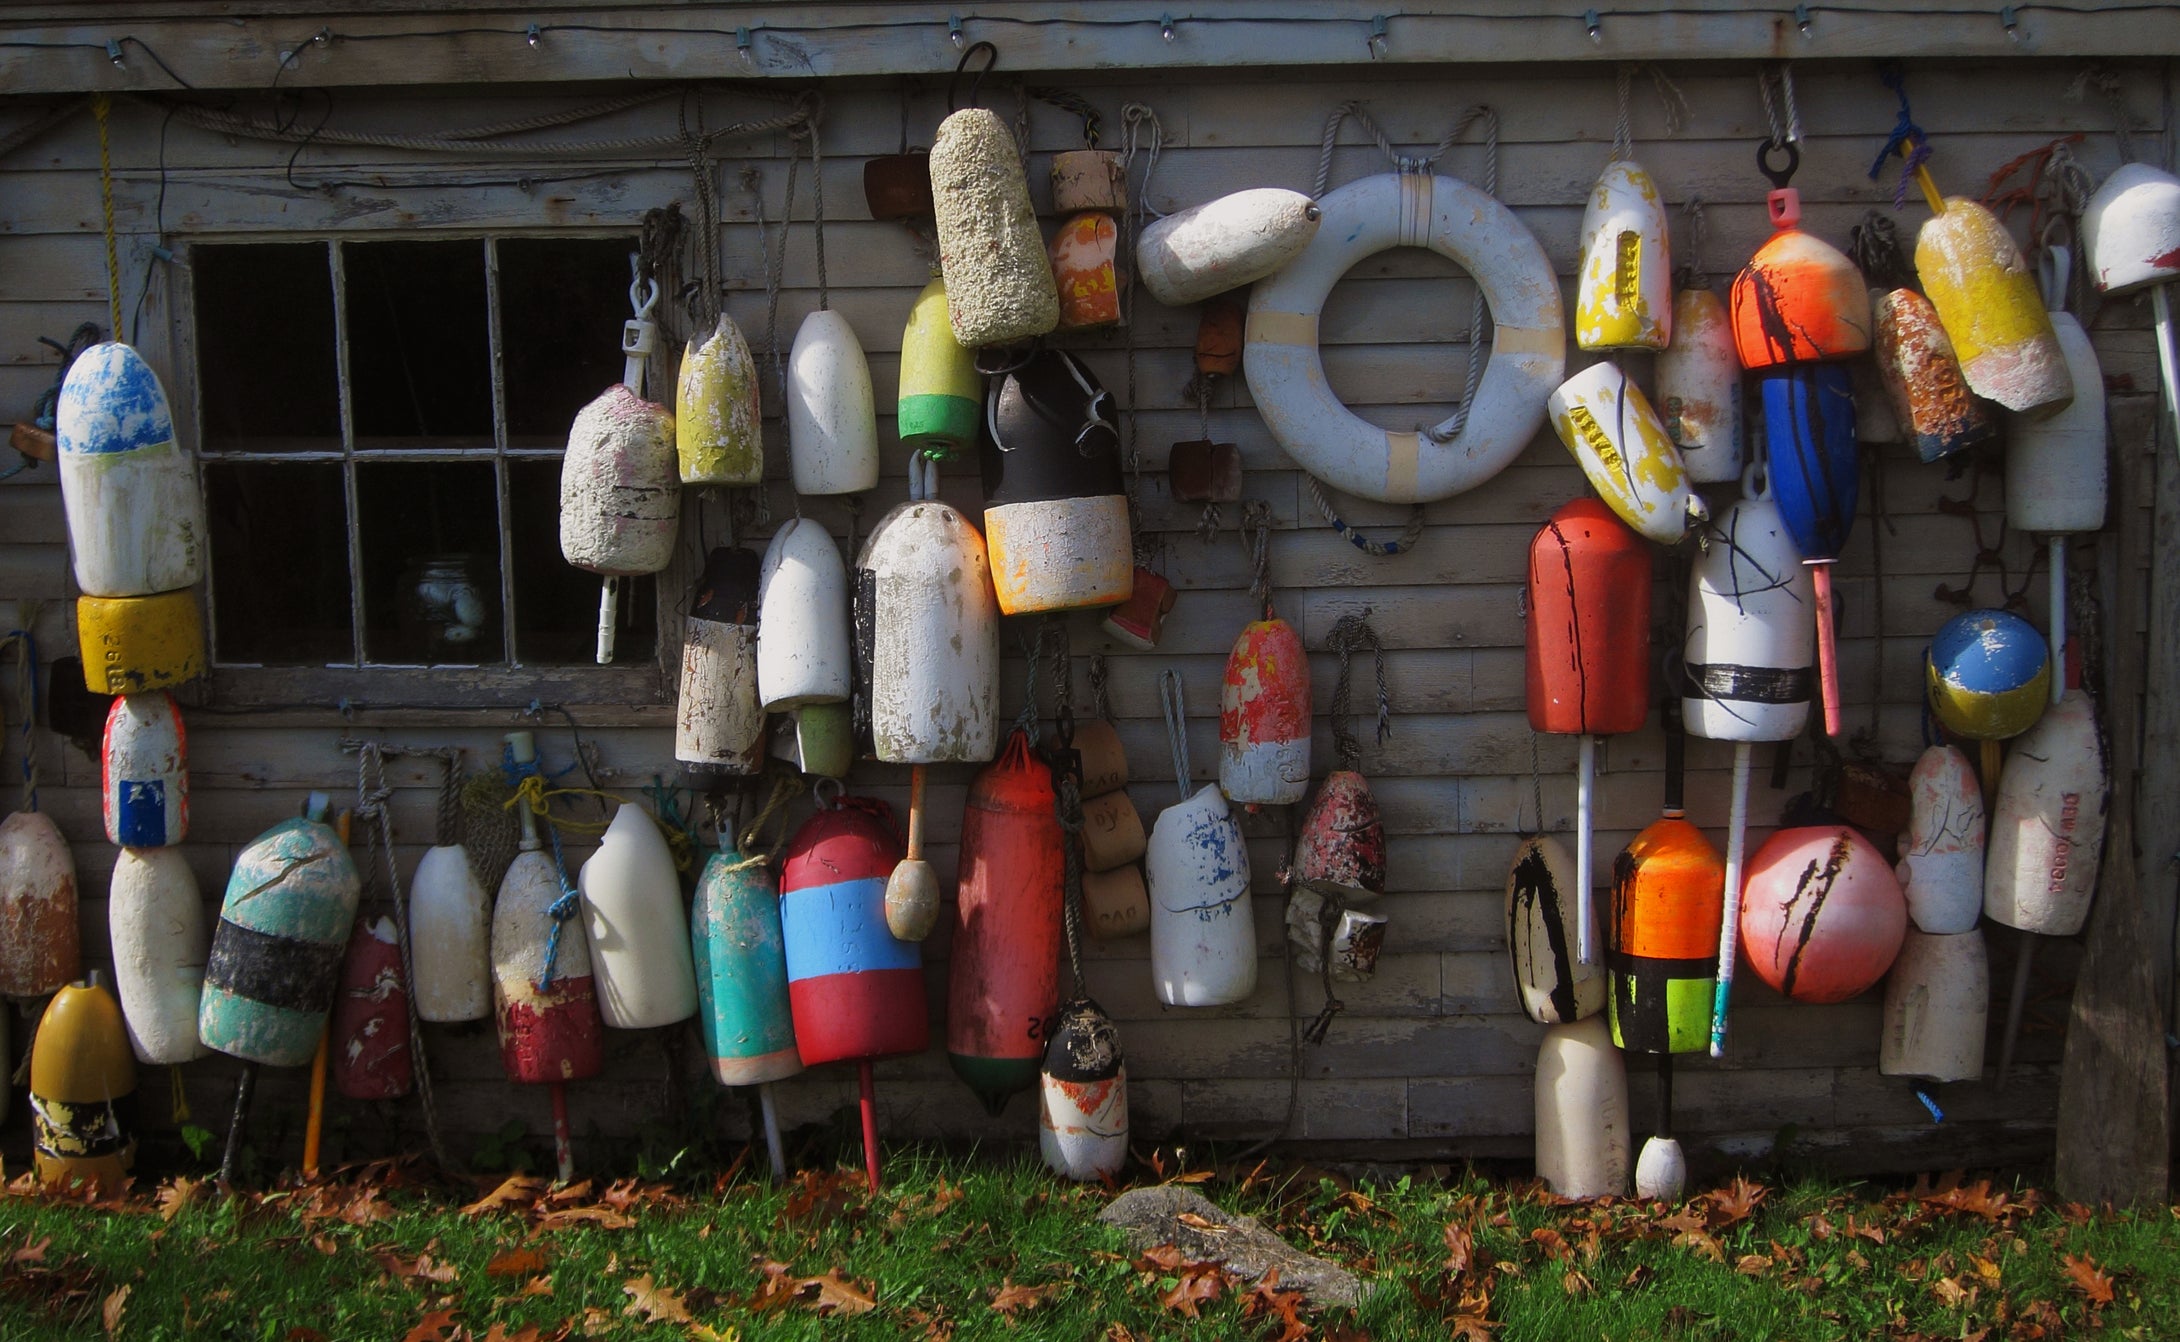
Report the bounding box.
[2056,397,2180,1207]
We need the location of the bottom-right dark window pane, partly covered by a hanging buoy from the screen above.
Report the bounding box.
[508,462,658,667]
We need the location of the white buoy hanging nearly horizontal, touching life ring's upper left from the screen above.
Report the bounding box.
[1136,187,1323,307]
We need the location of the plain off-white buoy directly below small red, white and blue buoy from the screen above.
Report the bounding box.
[107,847,211,1063]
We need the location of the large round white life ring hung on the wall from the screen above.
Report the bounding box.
[1245,172,1567,503]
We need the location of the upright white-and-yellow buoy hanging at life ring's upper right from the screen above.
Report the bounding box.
[1574,159,1674,349]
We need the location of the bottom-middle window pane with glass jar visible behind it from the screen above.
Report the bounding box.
[355,462,506,664]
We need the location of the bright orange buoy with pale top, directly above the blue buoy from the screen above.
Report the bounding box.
[1733,167,1870,373]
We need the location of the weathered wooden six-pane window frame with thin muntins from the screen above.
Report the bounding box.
[170,227,671,717]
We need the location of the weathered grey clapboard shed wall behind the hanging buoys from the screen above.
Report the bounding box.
[0,39,2171,1170]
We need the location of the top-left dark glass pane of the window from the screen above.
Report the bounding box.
[190,242,340,451]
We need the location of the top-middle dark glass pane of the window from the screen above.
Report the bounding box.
[340,240,493,449]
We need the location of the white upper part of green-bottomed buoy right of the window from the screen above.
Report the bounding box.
[756,516,855,712]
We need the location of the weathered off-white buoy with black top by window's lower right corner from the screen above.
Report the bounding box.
[674,545,765,779]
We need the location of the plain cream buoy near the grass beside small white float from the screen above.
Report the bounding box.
[1537,1015,1628,1198]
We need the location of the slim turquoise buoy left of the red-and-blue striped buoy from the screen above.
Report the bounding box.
[689,826,802,1085]
